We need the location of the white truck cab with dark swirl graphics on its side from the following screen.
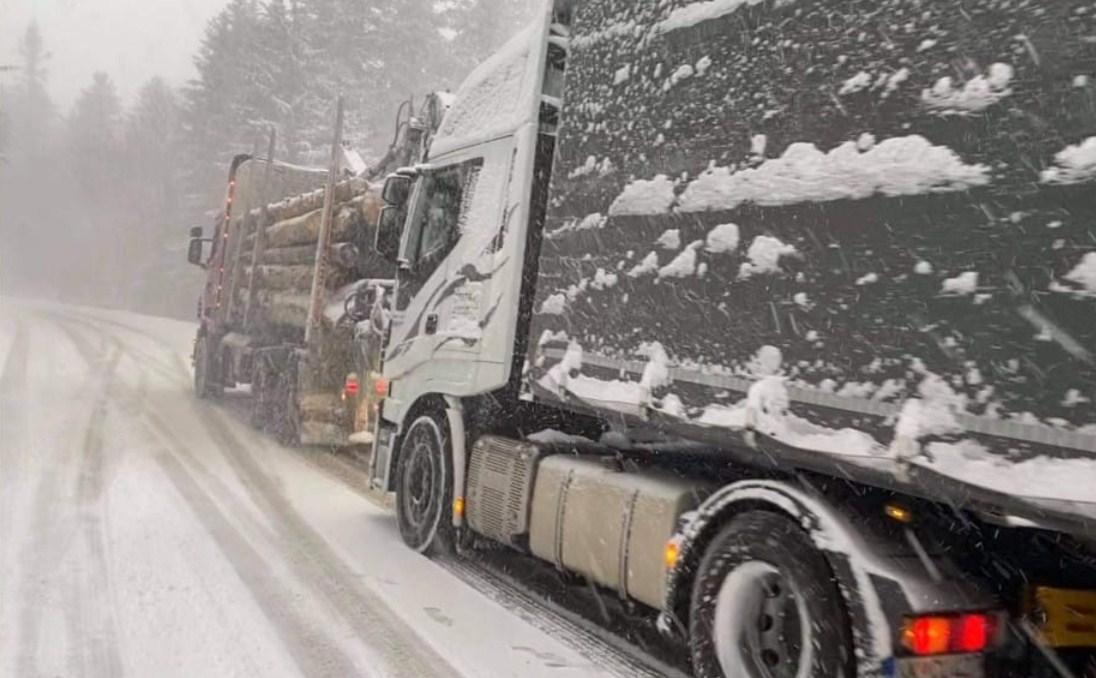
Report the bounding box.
[373,6,562,487]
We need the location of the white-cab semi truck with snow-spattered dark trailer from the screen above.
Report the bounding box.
[370,0,1096,678]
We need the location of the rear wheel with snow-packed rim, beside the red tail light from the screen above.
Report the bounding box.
[689,512,853,678]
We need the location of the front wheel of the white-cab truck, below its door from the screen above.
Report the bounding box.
[396,414,454,555]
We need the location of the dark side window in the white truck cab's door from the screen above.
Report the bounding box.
[408,159,483,270]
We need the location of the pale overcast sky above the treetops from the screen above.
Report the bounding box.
[0,0,227,112]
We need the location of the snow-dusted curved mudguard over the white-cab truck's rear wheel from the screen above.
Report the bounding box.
[659,480,893,676]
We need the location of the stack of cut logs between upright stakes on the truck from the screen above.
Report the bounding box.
[233,179,383,331]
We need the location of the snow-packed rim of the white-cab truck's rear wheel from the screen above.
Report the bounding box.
[712,561,813,678]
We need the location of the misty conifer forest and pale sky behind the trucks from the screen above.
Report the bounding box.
[0,0,537,318]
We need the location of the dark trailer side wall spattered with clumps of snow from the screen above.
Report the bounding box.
[527,0,1096,525]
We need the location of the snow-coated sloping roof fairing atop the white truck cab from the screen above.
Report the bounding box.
[431,20,547,158]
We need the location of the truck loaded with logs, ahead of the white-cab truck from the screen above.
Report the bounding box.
[187,94,445,446]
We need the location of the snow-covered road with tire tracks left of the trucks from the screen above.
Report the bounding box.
[0,299,666,678]
